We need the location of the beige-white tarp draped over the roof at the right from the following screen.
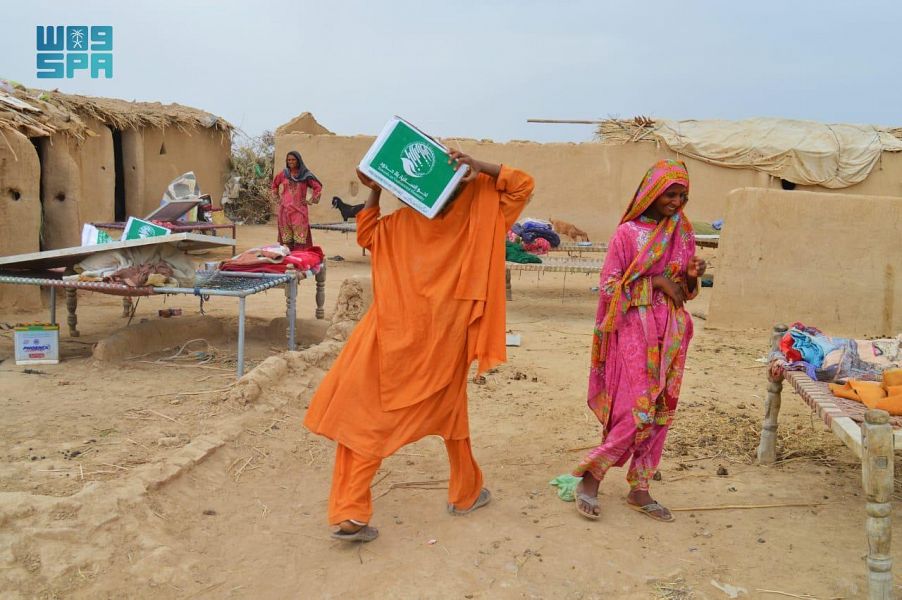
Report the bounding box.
[646,119,902,188]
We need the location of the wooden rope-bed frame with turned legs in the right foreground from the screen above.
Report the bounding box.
[758,325,902,600]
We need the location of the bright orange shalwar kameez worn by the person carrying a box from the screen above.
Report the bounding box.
[304,166,534,524]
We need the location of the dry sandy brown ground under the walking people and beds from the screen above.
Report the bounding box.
[0,226,900,600]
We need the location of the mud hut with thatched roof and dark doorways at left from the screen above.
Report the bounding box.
[0,82,232,306]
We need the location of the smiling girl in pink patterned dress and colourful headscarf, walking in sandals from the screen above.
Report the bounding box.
[573,160,706,521]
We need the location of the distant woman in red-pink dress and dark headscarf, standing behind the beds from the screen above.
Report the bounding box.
[272,150,323,250]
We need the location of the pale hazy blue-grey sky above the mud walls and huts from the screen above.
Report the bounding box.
[0,0,902,141]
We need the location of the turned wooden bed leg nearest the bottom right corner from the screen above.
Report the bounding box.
[861,409,893,600]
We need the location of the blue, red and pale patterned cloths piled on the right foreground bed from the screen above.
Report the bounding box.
[771,323,902,381]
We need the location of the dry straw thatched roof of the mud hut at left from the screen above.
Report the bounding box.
[0,81,233,140]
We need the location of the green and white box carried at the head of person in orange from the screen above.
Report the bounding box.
[358,117,468,219]
